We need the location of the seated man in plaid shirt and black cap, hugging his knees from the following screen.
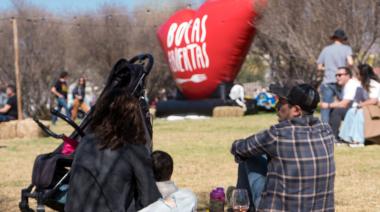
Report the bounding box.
[231,84,335,211]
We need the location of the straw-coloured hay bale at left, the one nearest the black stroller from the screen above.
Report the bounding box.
[16,119,49,138]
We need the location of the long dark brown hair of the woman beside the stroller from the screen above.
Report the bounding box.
[90,88,146,150]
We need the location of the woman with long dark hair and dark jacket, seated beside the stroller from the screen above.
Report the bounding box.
[65,88,161,212]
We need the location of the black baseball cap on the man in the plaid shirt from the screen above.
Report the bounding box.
[269,83,320,113]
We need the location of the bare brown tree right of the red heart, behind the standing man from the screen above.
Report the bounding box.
[254,0,380,85]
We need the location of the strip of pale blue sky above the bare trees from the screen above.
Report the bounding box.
[0,0,203,14]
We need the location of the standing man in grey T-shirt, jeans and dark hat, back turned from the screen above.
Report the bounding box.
[317,29,353,123]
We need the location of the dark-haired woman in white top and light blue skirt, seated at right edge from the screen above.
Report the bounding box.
[339,64,380,147]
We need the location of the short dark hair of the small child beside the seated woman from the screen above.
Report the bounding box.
[152,150,173,182]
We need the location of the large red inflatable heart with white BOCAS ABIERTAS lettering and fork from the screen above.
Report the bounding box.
[157,0,265,99]
